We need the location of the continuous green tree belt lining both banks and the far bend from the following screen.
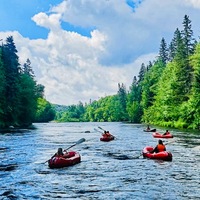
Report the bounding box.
[0,15,200,130]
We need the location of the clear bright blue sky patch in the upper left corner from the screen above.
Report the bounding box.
[0,0,62,39]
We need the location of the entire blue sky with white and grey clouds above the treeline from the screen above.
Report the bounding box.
[0,0,200,105]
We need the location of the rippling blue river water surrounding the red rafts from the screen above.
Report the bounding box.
[0,123,200,200]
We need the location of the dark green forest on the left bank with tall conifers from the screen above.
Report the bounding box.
[0,36,55,130]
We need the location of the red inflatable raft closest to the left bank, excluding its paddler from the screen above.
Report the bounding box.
[48,151,81,169]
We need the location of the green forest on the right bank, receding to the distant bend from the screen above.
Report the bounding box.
[54,15,200,129]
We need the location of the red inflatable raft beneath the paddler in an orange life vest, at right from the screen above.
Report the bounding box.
[142,146,172,161]
